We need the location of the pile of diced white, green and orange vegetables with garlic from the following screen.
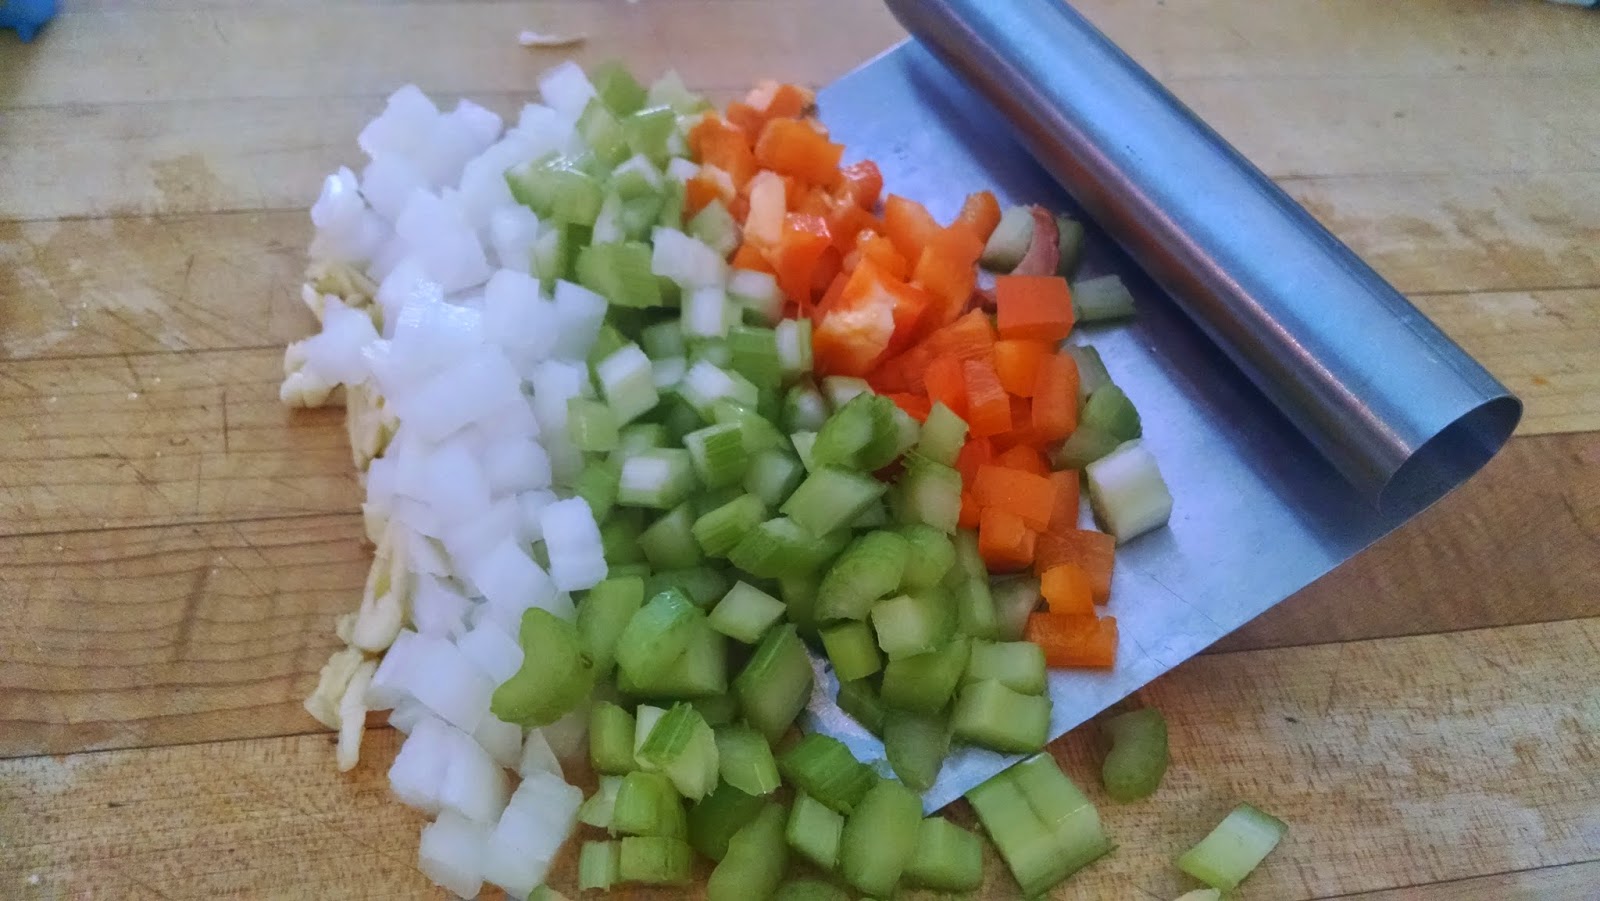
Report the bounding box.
[282,64,1282,899]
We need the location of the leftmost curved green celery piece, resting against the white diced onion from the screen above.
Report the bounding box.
[490,607,595,727]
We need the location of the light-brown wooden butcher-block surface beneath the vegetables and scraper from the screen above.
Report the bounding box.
[0,0,1600,901]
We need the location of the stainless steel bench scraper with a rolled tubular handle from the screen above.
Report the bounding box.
[808,0,1522,810]
